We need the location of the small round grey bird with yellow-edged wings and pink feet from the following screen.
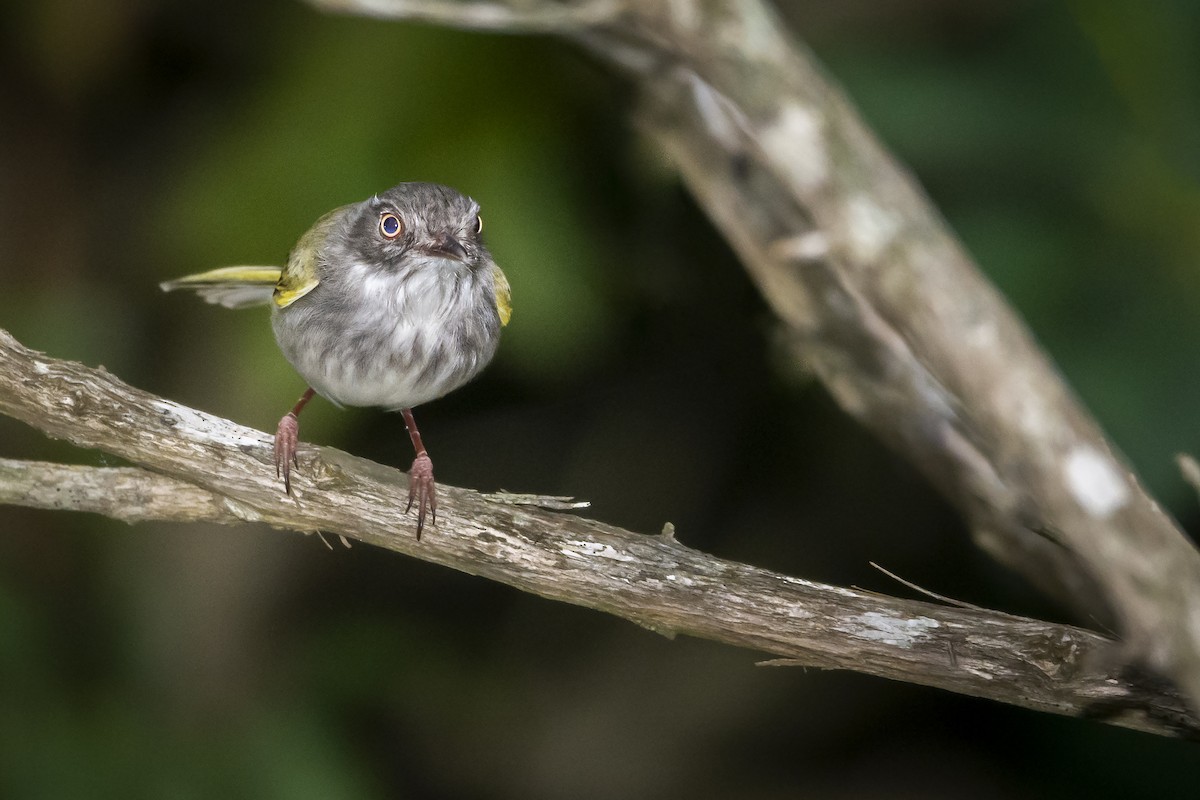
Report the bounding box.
[160,182,512,541]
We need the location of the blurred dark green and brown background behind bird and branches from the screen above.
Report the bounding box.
[0,0,1200,799]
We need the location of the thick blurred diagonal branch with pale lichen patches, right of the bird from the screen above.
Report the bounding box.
[312,0,1200,719]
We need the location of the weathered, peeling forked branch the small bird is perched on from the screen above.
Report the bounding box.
[0,331,1200,738]
